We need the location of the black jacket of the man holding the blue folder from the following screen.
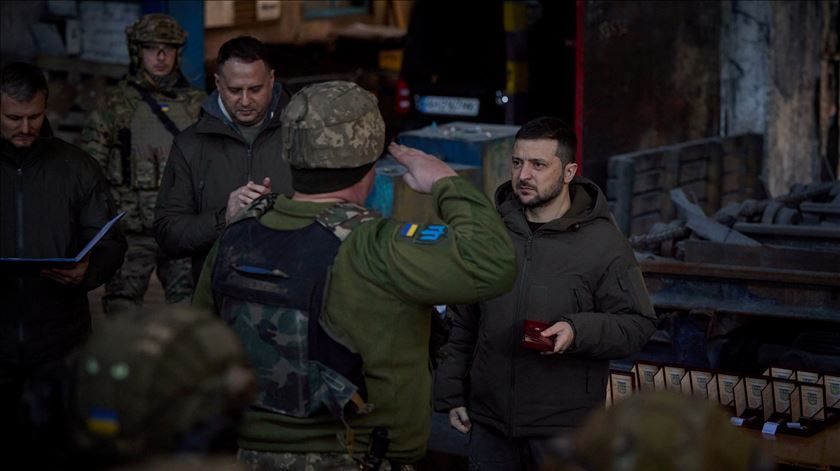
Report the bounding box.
[0,123,126,372]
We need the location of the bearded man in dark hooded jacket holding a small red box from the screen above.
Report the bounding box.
[435,118,656,470]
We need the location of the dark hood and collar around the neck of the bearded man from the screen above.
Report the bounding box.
[495,176,610,237]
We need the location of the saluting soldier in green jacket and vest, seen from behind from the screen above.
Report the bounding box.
[193,82,516,470]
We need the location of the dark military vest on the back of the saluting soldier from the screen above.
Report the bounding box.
[212,195,372,420]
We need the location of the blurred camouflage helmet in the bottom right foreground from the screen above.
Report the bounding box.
[542,391,774,471]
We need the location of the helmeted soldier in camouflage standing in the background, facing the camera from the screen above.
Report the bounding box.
[82,13,206,314]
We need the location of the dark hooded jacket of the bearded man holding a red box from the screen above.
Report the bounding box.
[435,177,656,437]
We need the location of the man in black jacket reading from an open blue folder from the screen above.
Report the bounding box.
[0,62,126,454]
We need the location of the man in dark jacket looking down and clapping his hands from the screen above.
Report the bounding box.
[154,37,292,281]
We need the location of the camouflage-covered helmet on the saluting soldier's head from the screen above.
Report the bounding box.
[280,81,385,169]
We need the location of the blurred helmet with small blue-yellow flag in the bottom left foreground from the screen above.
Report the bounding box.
[66,308,256,460]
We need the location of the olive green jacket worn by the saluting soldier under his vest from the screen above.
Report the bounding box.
[193,177,516,463]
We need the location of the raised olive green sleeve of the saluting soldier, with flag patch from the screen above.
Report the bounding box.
[345,177,516,305]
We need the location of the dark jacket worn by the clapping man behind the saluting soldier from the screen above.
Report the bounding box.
[154,84,292,281]
